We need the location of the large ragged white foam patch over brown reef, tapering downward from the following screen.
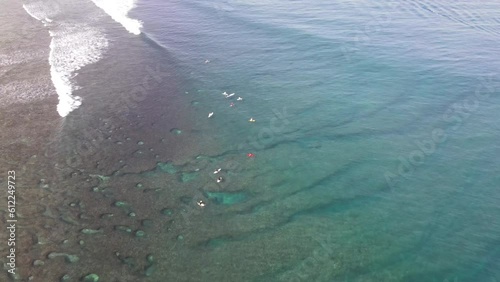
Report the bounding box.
[23,2,108,117]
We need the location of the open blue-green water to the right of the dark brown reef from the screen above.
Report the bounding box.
[134,1,500,281]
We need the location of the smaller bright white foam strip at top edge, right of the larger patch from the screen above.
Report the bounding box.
[88,0,142,35]
